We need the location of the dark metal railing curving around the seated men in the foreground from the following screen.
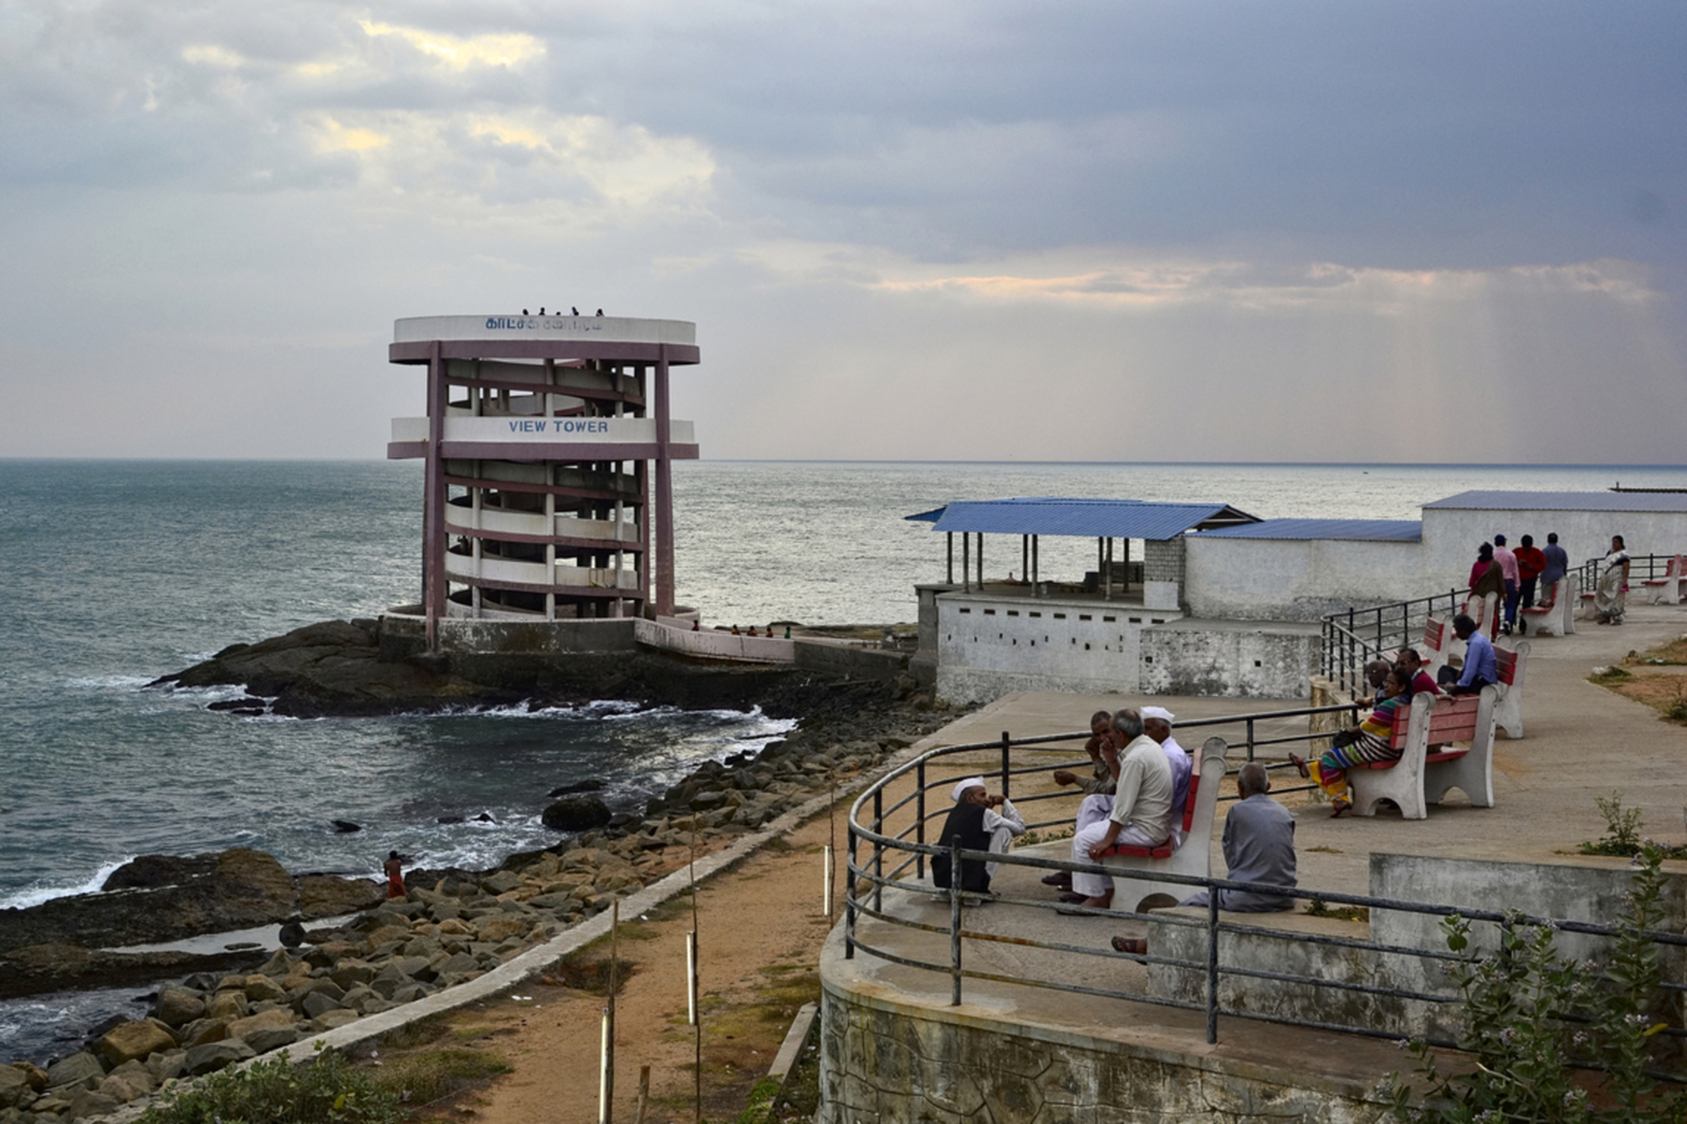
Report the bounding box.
[844,718,1687,1080]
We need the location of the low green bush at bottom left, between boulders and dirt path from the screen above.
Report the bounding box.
[138,1051,403,1124]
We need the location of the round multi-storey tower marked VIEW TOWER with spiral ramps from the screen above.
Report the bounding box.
[386,314,700,648]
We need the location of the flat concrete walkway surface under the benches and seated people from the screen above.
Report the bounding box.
[823,606,1687,1100]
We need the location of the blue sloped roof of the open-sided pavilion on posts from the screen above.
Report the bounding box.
[908,496,1253,542]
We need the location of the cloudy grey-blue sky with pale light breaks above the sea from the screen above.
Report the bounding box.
[0,0,1687,464]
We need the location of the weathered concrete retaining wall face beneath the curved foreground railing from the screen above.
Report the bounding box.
[817,927,1402,1124]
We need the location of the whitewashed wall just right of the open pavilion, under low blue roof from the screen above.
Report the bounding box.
[1183,535,1430,621]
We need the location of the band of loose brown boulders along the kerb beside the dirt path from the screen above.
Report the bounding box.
[0,684,953,1124]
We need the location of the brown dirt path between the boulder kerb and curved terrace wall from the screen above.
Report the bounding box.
[398,802,849,1124]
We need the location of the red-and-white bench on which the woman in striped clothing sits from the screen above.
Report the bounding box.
[1348,687,1496,820]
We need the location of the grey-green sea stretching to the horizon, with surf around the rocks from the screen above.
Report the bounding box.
[0,459,1687,1062]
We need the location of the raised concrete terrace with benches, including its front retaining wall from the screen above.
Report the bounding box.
[822,604,1687,1122]
